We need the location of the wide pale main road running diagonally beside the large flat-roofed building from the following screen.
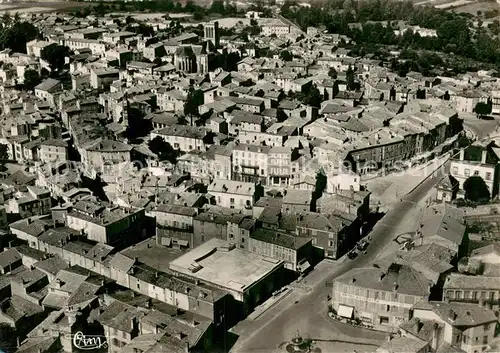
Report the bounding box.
[231,167,439,353]
